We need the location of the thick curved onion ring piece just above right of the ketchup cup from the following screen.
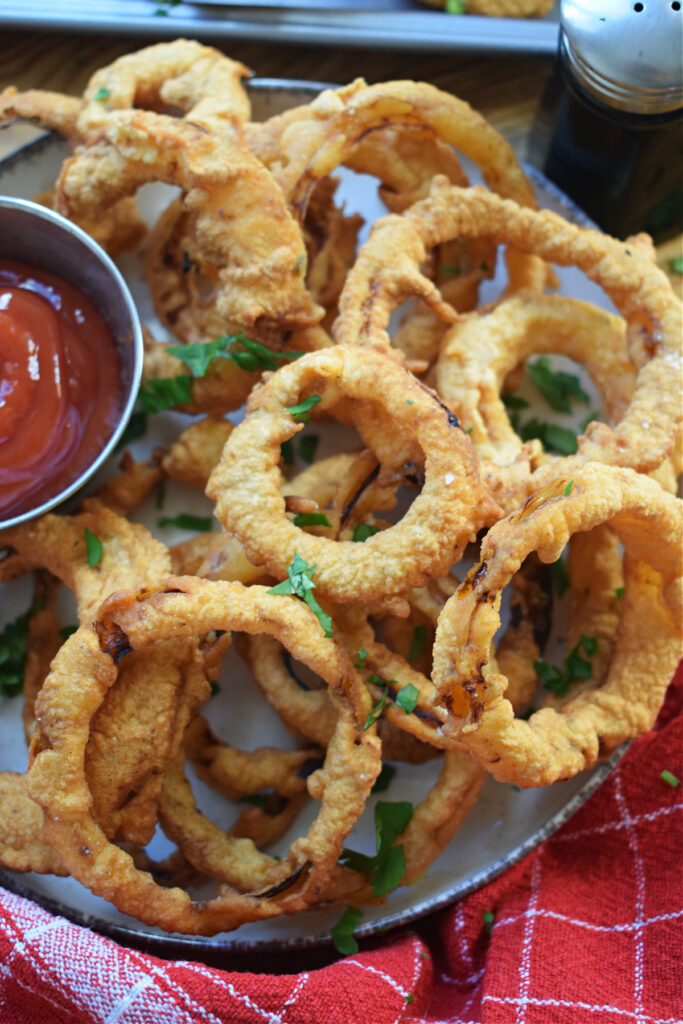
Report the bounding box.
[57,111,322,329]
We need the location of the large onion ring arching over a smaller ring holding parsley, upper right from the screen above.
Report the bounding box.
[336,179,683,479]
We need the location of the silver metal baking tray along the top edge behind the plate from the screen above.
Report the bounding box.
[0,0,558,55]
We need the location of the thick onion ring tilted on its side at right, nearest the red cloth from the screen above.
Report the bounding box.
[433,464,681,786]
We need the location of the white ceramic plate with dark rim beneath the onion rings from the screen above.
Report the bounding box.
[0,80,620,956]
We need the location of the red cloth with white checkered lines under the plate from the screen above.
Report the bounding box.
[0,667,683,1024]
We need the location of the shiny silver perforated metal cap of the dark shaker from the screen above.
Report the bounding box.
[560,0,683,114]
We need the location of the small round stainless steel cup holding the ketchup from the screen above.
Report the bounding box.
[0,196,143,529]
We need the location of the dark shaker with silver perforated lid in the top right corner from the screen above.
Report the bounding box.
[529,0,683,243]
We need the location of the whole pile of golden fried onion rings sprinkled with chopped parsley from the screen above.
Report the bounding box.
[0,46,683,935]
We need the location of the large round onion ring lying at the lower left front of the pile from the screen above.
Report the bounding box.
[30,578,380,934]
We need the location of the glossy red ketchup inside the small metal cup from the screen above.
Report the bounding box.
[0,260,121,518]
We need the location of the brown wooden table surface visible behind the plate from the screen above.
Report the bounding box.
[0,31,683,290]
